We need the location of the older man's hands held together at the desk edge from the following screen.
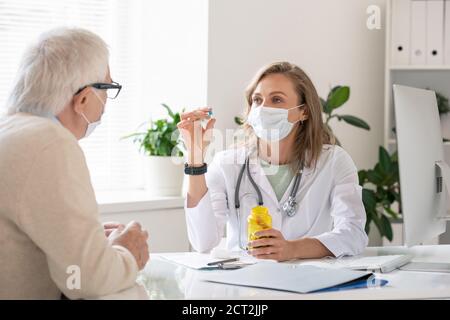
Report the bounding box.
[108,221,150,270]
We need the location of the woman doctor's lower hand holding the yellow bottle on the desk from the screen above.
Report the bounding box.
[248,229,295,261]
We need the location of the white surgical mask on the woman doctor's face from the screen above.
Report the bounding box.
[247,104,304,141]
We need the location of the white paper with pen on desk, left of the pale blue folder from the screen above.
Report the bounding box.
[161,252,258,270]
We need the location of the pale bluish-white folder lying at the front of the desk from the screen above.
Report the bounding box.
[202,263,372,293]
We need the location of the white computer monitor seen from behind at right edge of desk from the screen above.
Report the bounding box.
[394,85,450,247]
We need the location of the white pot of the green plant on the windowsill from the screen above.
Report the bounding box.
[144,156,184,197]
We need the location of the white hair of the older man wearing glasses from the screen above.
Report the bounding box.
[7,28,109,116]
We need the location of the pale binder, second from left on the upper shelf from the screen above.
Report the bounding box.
[412,0,427,65]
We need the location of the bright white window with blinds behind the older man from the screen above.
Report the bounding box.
[0,0,207,191]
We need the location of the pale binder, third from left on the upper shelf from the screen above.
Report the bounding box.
[426,0,444,65]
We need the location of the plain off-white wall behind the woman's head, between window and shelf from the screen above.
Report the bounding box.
[208,0,385,169]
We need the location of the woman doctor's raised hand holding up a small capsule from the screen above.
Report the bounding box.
[177,108,216,166]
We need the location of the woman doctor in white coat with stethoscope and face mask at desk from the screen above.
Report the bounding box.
[178,62,367,261]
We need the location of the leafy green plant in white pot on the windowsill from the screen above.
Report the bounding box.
[123,104,184,196]
